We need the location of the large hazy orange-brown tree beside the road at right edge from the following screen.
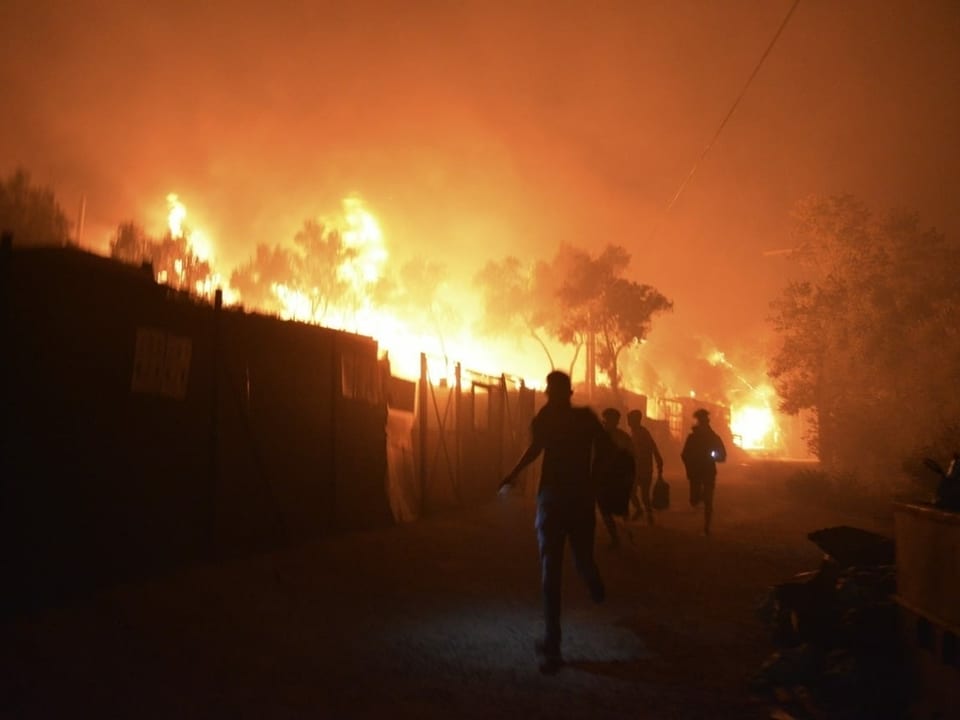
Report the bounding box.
[769,196,960,476]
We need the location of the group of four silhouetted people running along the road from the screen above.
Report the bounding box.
[500,371,726,672]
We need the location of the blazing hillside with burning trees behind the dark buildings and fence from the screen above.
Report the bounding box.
[112,193,796,450]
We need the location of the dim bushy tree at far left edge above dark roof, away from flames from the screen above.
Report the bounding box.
[0,169,70,245]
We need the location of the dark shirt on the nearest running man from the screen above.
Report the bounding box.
[530,403,607,503]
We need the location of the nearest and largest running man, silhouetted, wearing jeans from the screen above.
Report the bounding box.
[501,371,610,672]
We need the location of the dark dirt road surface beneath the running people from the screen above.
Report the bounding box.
[0,463,892,718]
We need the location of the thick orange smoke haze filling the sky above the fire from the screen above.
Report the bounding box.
[0,0,960,380]
